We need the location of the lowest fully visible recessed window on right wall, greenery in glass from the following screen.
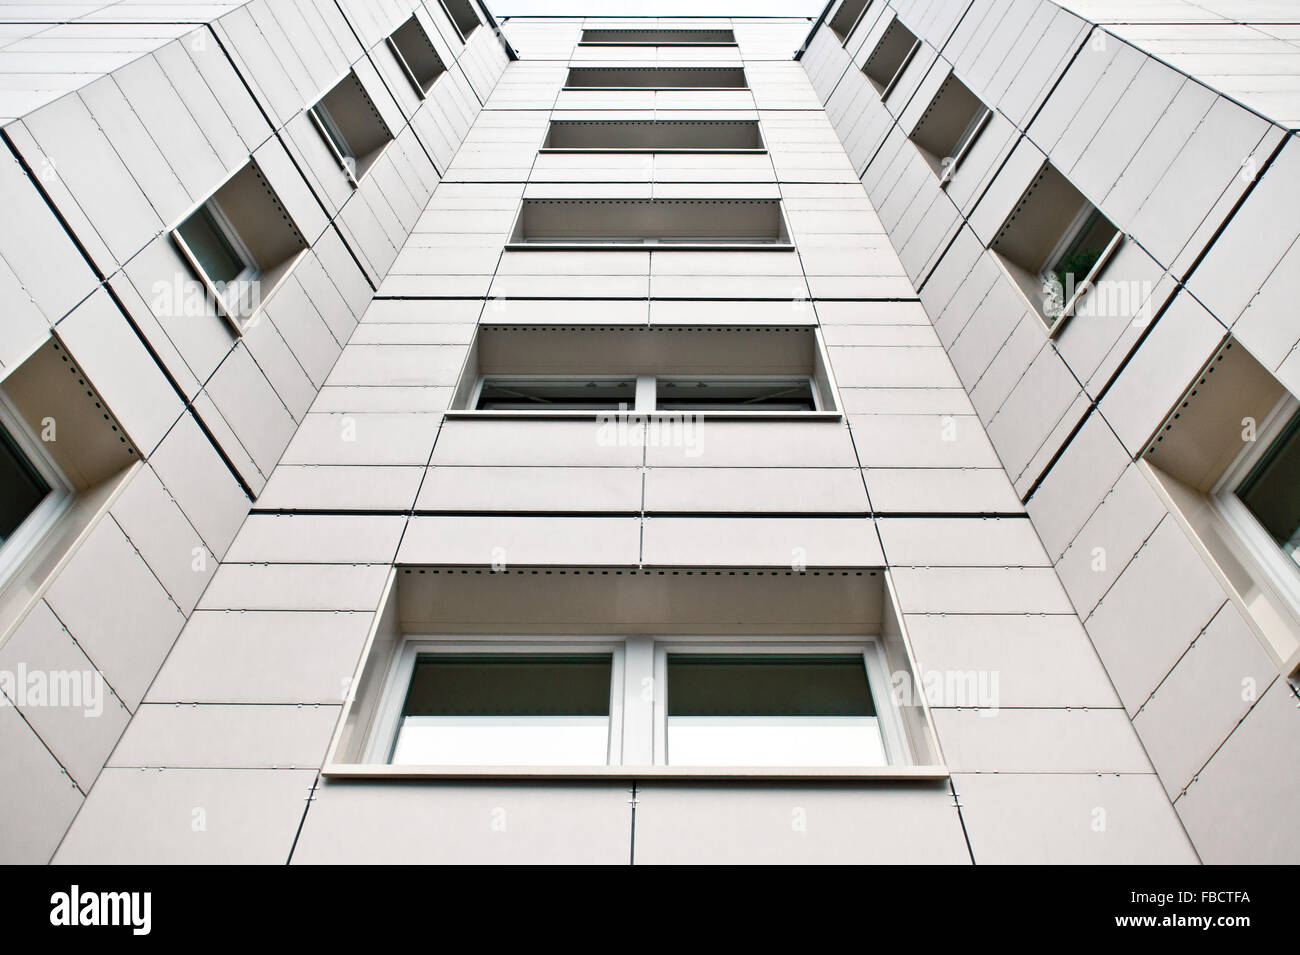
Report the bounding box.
[991,164,1123,329]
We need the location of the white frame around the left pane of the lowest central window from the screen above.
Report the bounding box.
[364,634,625,770]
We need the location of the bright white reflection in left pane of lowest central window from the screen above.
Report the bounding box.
[391,716,610,767]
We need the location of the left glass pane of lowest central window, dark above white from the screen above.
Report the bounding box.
[391,654,612,765]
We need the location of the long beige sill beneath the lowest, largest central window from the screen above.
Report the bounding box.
[321,763,949,782]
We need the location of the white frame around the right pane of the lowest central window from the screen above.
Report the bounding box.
[654,637,913,769]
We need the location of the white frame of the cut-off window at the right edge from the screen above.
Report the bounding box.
[1209,394,1300,617]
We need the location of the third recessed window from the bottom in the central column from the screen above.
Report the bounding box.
[510,199,790,249]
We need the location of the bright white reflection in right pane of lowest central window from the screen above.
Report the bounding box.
[668,716,889,767]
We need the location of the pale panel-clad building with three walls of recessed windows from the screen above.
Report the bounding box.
[0,0,1300,864]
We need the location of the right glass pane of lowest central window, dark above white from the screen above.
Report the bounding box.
[666,652,889,767]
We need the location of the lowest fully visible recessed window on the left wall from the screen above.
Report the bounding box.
[172,162,307,333]
